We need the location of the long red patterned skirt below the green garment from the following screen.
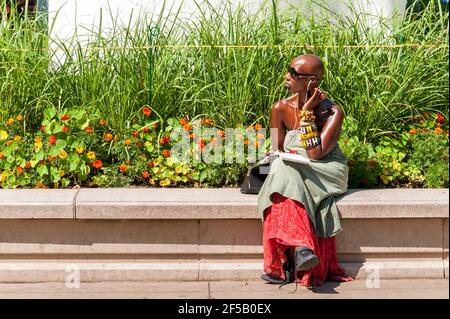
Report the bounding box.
[263,193,353,287]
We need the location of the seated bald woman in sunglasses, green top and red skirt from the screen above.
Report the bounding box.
[258,55,352,287]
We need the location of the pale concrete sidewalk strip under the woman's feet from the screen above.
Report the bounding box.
[0,279,449,299]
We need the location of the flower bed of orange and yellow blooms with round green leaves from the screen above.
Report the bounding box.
[0,106,448,188]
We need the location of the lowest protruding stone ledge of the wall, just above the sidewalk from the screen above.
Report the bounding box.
[0,259,443,283]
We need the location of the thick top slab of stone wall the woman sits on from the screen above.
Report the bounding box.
[0,188,449,219]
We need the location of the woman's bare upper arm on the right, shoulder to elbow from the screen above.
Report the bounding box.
[306,105,344,160]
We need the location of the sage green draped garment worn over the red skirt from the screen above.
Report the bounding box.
[258,130,348,237]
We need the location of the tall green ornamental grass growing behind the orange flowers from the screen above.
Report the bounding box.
[0,1,449,141]
